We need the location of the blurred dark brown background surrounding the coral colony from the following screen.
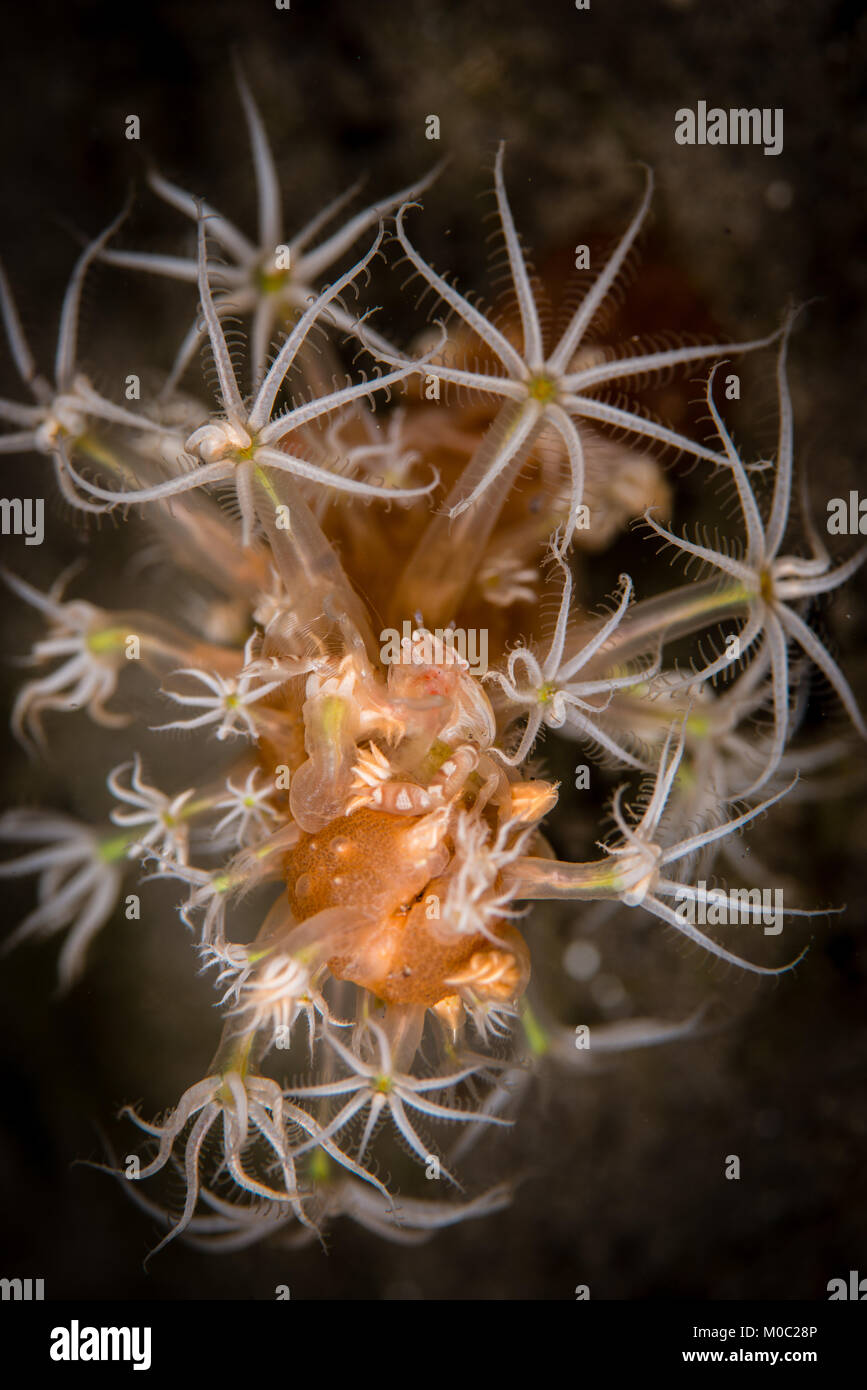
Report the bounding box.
[0,0,867,1300]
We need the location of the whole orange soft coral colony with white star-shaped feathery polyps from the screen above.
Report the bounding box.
[0,67,864,1248]
